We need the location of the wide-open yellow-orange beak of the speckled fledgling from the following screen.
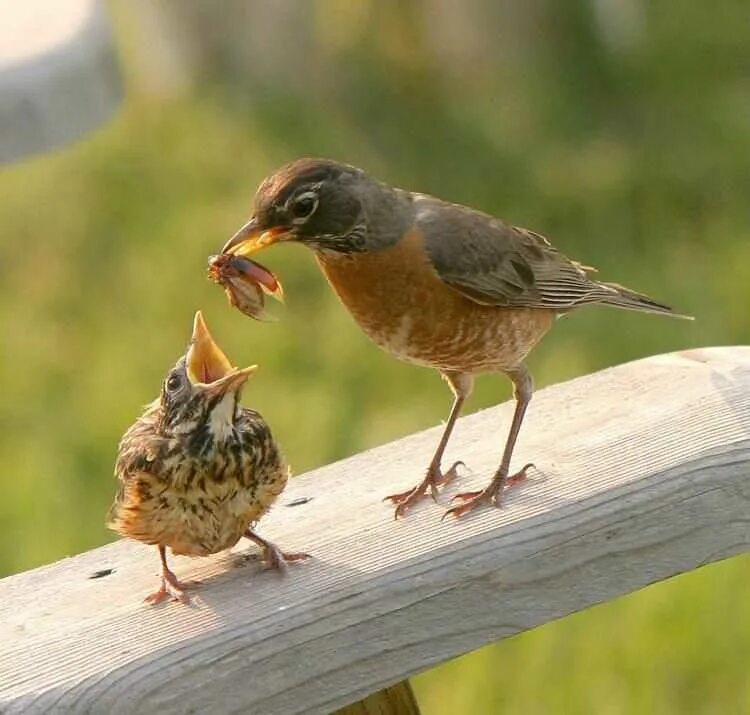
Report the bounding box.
[186,310,258,394]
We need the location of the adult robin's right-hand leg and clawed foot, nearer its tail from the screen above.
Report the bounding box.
[443,365,534,518]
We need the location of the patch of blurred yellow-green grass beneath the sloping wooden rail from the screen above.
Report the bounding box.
[412,557,750,715]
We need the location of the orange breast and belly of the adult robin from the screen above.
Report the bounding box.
[317,229,554,372]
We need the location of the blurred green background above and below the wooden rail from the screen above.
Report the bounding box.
[0,0,750,715]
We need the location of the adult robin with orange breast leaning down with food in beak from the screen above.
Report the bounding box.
[223,159,692,518]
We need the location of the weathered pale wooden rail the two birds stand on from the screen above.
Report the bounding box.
[0,347,750,715]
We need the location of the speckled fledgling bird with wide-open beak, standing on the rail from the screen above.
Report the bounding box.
[108,311,308,603]
